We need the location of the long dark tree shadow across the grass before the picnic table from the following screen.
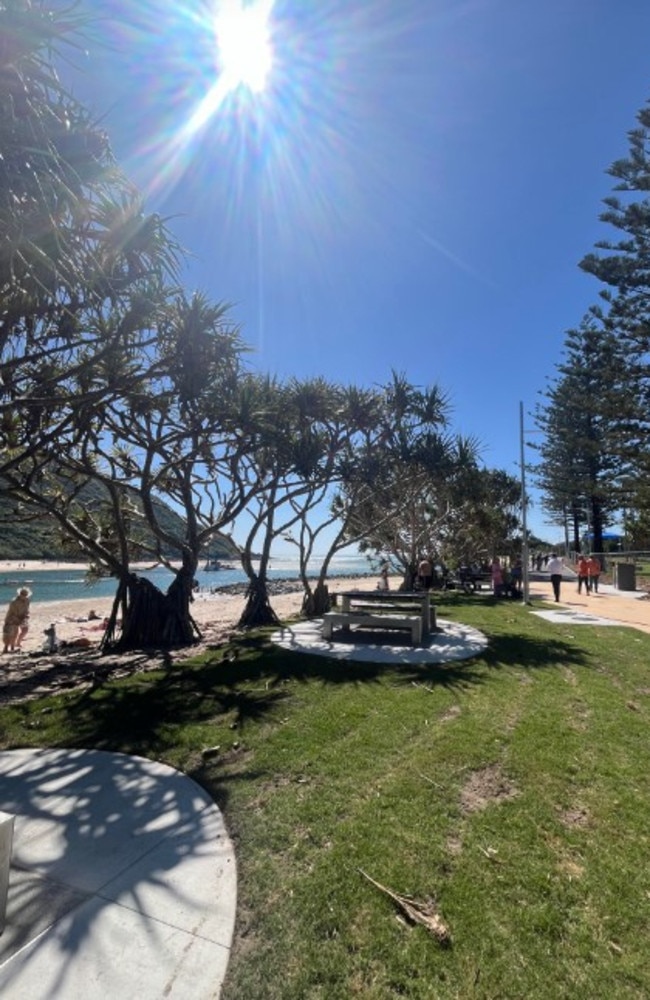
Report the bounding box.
[63,634,587,753]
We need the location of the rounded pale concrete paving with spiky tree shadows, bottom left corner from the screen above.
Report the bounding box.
[0,749,237,1000]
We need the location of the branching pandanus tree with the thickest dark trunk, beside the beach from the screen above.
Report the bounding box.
[4,295,259,650]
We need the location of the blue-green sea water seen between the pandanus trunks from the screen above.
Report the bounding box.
[0,555,373,604]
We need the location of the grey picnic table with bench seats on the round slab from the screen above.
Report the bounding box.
[323,590,436,645]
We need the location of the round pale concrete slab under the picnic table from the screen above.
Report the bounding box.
[272,618,488,664]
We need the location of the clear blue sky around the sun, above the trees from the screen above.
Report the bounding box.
[64,0,650,539]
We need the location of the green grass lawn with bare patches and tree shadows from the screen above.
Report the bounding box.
[0,593,650,1000]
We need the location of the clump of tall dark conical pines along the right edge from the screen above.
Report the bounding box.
[538,97,650,550]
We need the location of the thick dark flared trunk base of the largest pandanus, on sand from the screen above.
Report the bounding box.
[101,570,201,653]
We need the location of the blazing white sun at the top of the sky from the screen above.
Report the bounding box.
[215,0,273,93]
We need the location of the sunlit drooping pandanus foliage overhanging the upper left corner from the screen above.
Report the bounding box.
[0,0,177,476]
